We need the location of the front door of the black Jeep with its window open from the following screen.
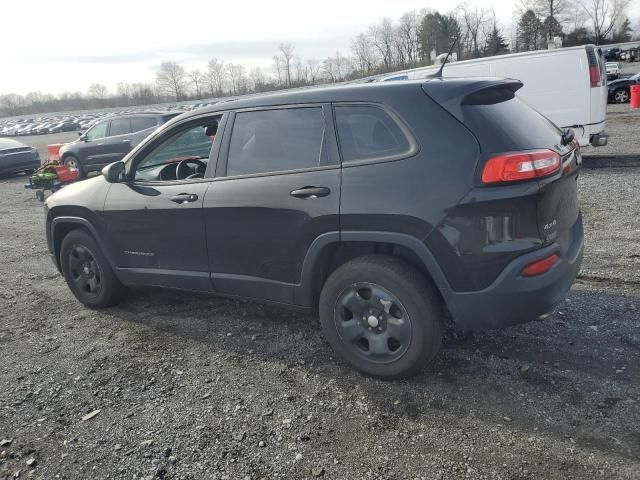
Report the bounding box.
[103,118,222,290]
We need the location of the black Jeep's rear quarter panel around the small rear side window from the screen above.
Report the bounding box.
[336,87,480,248]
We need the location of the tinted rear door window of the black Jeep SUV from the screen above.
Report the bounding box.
[227,107,324,176]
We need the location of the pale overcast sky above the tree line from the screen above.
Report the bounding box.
[0,0,636,94]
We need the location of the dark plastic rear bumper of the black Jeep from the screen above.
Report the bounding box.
[447,218,584,330]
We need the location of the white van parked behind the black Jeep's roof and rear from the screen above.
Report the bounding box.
[373,45,608,147]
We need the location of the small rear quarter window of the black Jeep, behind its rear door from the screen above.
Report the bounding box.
[335,105,411,162]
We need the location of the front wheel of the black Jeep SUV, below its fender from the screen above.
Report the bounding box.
[60,230,123,308]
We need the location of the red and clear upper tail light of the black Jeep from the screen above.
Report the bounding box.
[482,150,560,183]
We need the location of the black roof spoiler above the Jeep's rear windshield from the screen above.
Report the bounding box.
[422,78,524,122]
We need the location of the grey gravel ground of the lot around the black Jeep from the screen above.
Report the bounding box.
[0,112,640,480]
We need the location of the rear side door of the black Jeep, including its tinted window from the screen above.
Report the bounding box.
[204,105,340,304]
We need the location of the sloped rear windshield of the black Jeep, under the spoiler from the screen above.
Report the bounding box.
[462,89,562,153]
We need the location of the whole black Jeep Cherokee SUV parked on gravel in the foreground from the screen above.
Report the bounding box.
[46,78,583,378]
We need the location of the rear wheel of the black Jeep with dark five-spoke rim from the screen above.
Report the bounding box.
[319,255,443,380]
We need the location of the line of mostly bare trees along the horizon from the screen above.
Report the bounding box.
[0,0,635,116]
